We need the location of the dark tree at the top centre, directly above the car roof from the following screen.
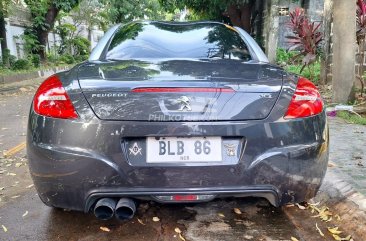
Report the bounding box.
[159,0,260,33]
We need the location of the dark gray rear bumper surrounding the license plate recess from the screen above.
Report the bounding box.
[27,110,328,212]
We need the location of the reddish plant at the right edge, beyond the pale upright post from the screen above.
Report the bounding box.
[356,0,366,96]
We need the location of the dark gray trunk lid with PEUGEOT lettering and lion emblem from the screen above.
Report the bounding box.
[78,59,283,121]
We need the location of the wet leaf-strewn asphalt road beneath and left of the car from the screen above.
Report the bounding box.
[0,83,358,241]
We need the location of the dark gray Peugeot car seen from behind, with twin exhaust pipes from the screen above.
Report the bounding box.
[27,22,328,219]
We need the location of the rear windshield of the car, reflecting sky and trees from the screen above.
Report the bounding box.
[106,22,252,61]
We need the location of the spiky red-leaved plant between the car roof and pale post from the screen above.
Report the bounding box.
[286,8,323,80]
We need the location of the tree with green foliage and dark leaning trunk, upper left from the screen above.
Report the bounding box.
[25,0,79,62]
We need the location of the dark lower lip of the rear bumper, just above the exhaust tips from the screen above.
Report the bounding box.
[84,185,280,212]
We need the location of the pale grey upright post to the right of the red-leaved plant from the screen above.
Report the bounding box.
[332,0,356,103]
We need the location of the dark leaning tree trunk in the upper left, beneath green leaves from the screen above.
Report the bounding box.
[36,4,60,62]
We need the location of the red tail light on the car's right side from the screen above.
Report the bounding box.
[285,77,323,119]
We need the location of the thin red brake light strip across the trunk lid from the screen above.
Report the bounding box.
[132,87,235,93]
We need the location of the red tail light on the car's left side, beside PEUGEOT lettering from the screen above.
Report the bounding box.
[33,75,78,119]
